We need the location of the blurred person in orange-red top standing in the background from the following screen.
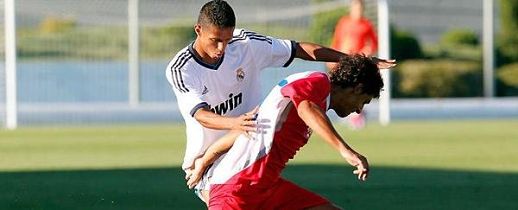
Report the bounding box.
[327,0,378,130]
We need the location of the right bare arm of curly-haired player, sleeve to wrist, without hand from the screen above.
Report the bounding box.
[297,101,355,157]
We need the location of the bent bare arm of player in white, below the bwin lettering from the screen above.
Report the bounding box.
[194,107,258,132]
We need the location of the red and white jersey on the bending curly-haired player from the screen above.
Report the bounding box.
[208,72,331,188]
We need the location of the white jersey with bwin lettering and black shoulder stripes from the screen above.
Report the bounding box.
[166,29,296,170]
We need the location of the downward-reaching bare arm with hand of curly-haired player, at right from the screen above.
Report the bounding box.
[297,100,369,181]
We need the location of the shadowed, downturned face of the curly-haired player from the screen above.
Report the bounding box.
[333,88,373,117]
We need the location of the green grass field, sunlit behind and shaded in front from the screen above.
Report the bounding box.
[0,120,518,210]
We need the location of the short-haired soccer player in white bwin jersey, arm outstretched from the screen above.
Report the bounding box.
[166,0,395,203]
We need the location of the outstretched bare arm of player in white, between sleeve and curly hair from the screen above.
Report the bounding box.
[296,42,347,62]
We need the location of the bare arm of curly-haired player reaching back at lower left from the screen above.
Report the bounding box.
[186,130,242,189]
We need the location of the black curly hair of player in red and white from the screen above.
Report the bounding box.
[329,54,383,98]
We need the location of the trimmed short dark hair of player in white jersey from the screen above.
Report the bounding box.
[198,0,236,28]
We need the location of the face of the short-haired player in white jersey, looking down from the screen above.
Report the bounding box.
[194,24,234,63]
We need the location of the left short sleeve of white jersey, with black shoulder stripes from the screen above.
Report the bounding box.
[166,57,208,117]
